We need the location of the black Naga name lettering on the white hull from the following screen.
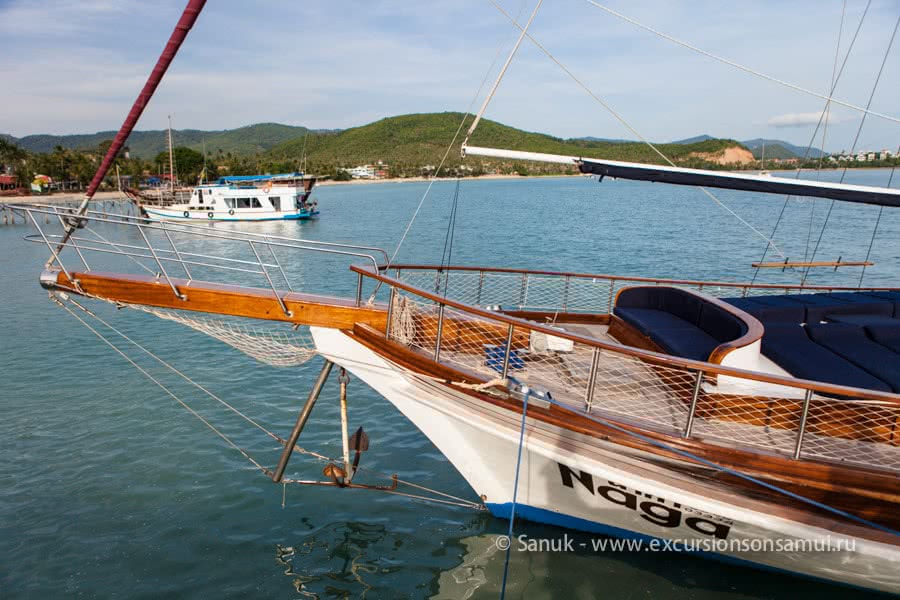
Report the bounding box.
[557,463,732,540]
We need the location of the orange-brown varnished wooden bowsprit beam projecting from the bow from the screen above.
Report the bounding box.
[56,271,387,331]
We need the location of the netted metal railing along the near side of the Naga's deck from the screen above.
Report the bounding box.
[353,267,900,472]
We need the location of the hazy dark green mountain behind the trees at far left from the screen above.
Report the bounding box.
[0,123,336,159]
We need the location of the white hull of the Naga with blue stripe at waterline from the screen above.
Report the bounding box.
[312,328,900,593]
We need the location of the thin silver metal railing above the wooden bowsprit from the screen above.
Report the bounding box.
[6,204,387,316]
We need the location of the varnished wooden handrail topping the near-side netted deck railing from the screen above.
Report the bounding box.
[350,265,900,407]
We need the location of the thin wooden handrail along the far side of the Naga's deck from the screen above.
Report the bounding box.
[382,264,900,292]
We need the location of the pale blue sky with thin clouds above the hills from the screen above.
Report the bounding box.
[0,0,900,150]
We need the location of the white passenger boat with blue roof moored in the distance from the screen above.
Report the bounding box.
[138,173,319,221]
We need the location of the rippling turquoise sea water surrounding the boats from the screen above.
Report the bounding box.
[0,170,900,599]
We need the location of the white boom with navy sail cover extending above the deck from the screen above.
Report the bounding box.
[463,146,900,207]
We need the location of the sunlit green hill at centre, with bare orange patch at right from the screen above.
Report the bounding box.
[268,112,740,174]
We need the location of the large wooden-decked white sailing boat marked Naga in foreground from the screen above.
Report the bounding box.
[3,0,900,593]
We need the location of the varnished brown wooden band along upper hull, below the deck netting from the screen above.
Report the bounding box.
[346,325,900,545]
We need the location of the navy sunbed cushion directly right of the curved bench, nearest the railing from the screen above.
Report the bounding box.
[762,325,891,392]
